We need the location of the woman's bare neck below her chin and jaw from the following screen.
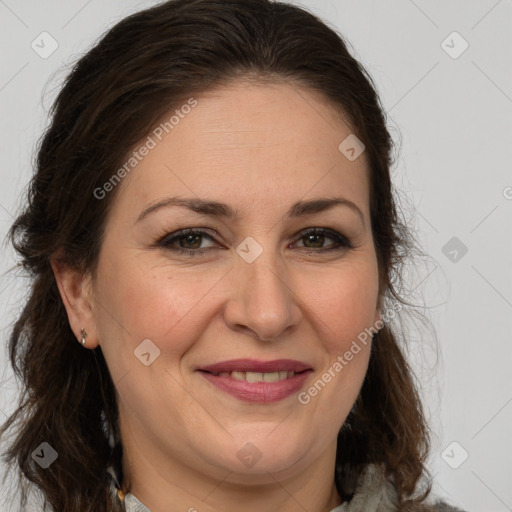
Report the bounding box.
[123,426,341,512]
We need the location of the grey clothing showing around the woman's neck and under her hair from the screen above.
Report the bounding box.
[109,464,464,512]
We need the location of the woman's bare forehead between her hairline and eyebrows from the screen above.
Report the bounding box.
[109,82,368,221]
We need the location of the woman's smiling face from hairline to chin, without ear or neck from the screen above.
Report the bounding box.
[85,83,380,480]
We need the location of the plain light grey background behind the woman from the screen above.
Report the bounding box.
[0,0,512,512]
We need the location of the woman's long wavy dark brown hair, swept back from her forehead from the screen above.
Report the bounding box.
[0,0,431,512]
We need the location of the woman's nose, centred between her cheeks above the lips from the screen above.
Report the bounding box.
[224,246,302,341]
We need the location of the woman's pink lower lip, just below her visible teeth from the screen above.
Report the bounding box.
[199,370,312,403]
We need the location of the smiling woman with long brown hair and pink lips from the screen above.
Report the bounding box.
[2,0,466,512]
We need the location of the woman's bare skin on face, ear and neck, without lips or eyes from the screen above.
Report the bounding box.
[53,82,381,512]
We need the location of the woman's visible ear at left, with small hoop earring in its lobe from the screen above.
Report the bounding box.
[50,256,98,348]
